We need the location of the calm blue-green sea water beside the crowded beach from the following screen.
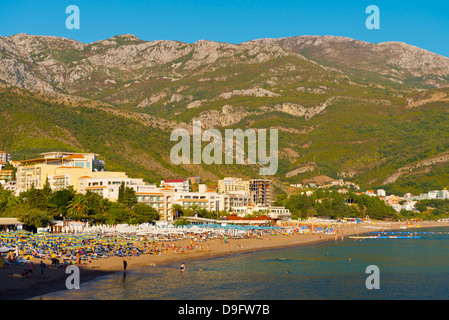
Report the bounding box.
[39,228,449,300]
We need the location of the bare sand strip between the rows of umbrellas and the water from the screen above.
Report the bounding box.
[0,222,449,300]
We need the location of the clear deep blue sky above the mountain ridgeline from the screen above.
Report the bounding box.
[0,0,449,57]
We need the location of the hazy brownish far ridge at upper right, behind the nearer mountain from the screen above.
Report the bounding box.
[247,36,449,88]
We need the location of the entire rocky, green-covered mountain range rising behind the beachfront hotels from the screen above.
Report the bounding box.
[0,34,449,193]
